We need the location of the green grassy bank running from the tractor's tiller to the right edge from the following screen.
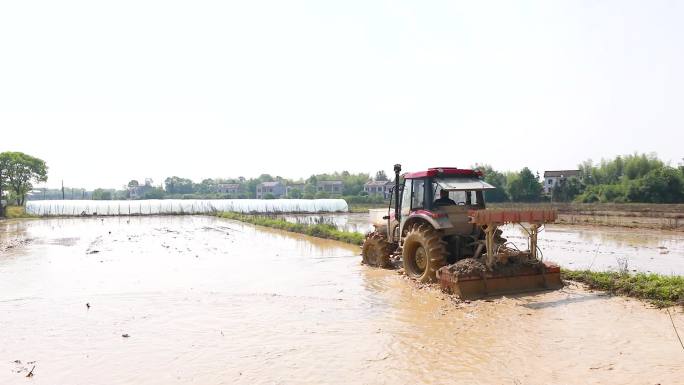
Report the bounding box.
[561,269,684,307]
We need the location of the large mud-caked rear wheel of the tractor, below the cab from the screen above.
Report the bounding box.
[402,224,447,283]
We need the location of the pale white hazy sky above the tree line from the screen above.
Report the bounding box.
[0,0,684,188]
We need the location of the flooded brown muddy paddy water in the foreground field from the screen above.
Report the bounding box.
[0,217,684,384]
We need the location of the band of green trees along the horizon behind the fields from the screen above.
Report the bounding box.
[0,152,684,216]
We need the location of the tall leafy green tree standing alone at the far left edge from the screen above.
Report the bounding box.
[0,152,48,206]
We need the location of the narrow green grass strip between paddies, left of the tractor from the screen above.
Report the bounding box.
[217,212,365,245]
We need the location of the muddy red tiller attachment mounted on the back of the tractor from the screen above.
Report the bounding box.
[437,210,563,299]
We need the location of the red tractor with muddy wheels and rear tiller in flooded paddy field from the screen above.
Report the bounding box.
[362,164,561,297]
